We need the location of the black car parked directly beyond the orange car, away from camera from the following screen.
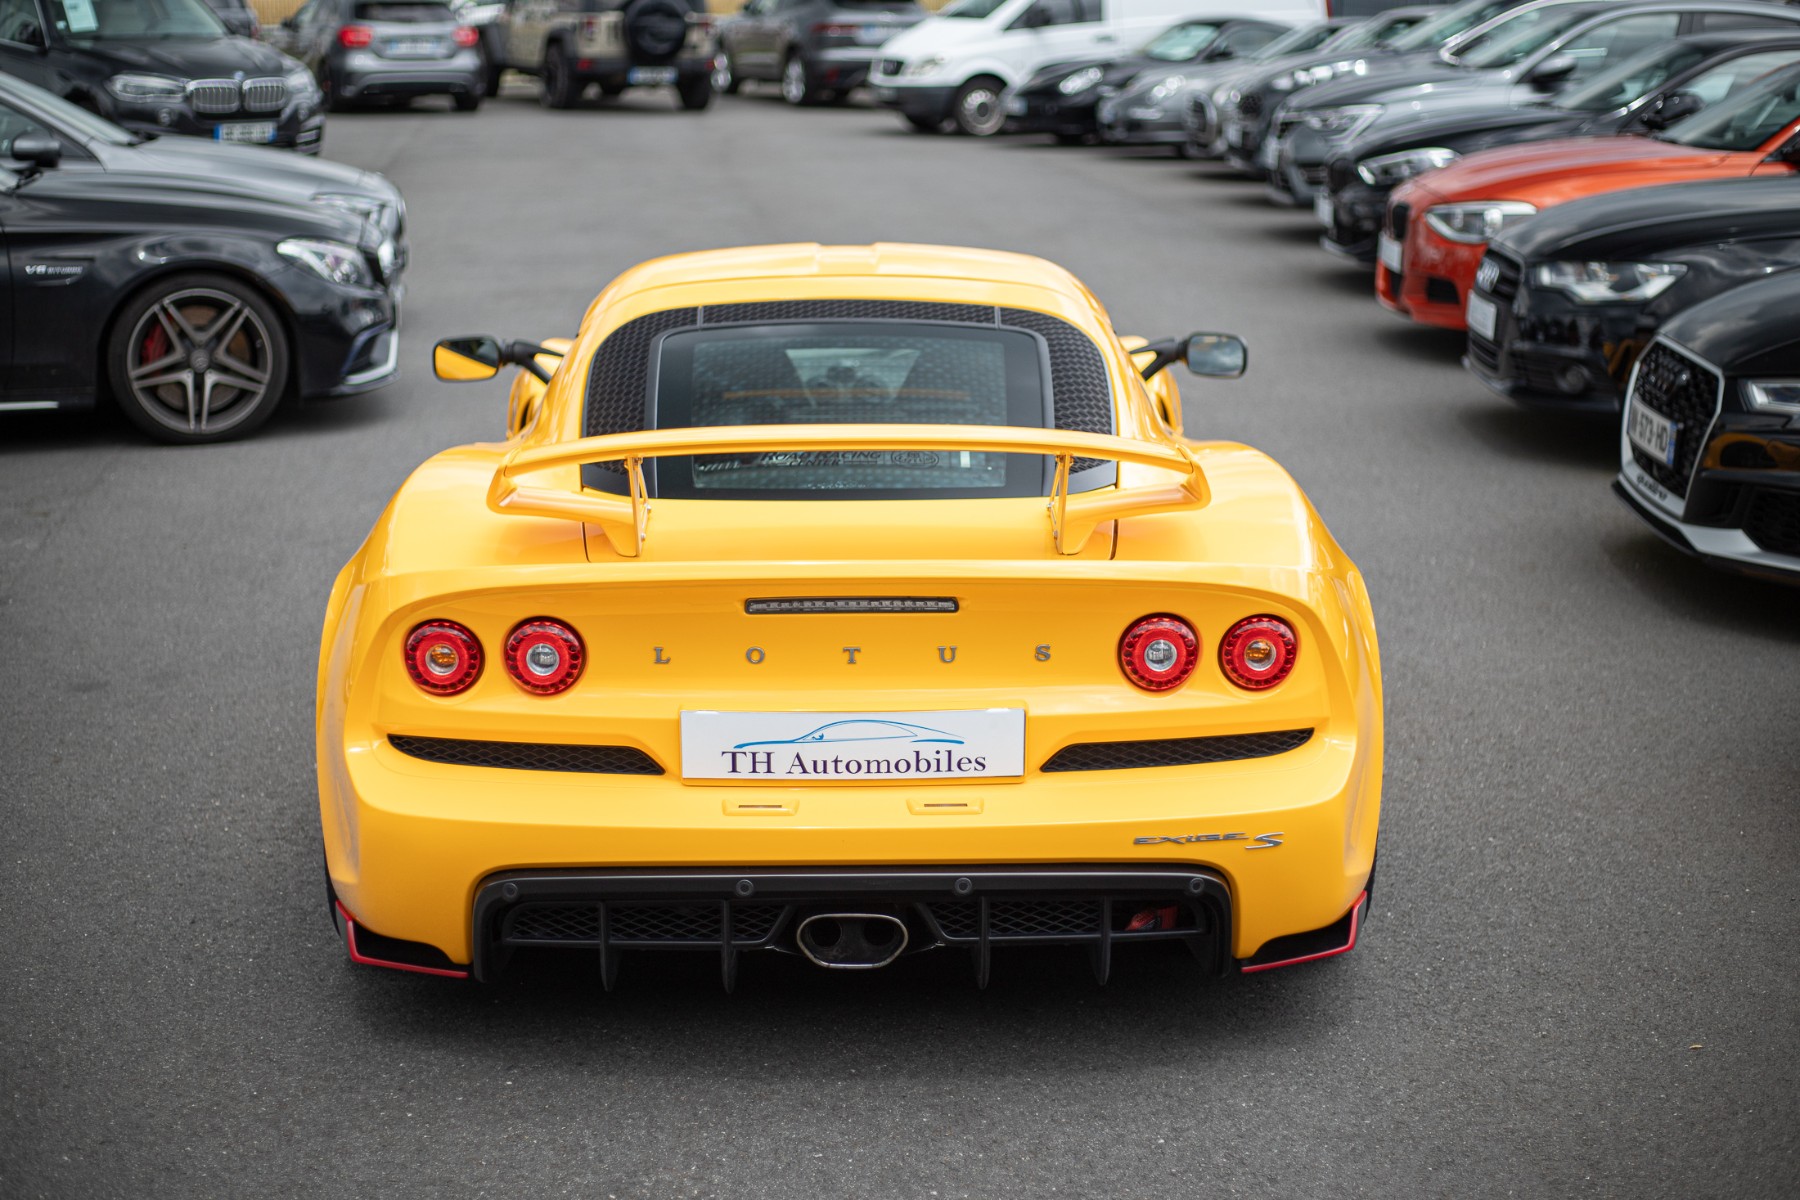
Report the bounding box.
[1317,29,1800,263]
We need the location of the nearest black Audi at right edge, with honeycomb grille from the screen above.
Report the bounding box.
[1613,272,1800,585]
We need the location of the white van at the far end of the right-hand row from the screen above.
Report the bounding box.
[869,0,1325,137]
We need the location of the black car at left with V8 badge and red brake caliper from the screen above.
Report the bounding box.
[0,133,400,443]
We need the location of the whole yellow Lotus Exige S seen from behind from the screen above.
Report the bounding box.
[317,245,1382,986]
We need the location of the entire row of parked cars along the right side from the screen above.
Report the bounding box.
[860,0,1800,583]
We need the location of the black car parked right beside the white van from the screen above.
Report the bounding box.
[1006,20,1287,144]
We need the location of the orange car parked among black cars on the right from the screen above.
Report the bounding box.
[1375,67,1800,336]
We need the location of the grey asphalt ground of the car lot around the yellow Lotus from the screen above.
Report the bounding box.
[0,79,1800,1200]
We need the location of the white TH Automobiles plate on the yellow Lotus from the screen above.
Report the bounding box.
[680,709,1024,784]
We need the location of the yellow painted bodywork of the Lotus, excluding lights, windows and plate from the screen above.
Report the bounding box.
[317,245,1382,963]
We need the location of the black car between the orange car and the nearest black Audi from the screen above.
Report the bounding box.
[1463,175,1800,412]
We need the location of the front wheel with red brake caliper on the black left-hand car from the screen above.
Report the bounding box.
[106,272,292,444]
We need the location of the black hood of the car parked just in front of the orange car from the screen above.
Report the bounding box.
[1494,178,1800,263]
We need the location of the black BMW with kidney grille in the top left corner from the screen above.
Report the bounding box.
[0,0,324,155]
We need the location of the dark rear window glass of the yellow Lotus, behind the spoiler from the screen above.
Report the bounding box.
[652,322,1053,500]
